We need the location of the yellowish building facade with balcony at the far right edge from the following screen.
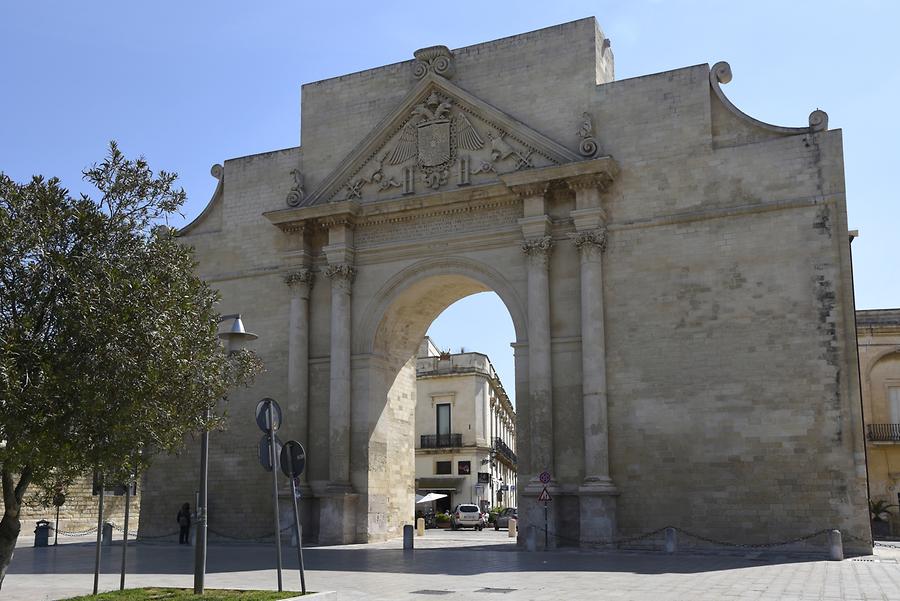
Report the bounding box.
[856,309,900,538]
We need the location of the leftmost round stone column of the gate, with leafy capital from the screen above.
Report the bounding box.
[285,268,313,496]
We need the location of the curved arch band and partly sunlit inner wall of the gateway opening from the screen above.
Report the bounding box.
[351,257,526,540]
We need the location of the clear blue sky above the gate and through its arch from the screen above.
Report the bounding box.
[0,0,900,400]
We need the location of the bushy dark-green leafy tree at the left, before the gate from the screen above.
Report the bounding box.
[0,142,260,585]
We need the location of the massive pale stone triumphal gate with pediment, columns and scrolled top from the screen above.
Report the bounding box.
[141,19,868,546]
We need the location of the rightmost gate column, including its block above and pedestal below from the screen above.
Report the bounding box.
[567,175,618,546]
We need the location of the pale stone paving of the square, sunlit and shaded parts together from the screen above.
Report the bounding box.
[0,530,900,601]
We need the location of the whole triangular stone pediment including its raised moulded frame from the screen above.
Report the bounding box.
[303,73,582,205]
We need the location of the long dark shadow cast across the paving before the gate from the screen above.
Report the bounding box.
[8,542,824,576]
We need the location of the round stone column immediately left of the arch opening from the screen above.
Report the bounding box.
[325,263,355,493]
